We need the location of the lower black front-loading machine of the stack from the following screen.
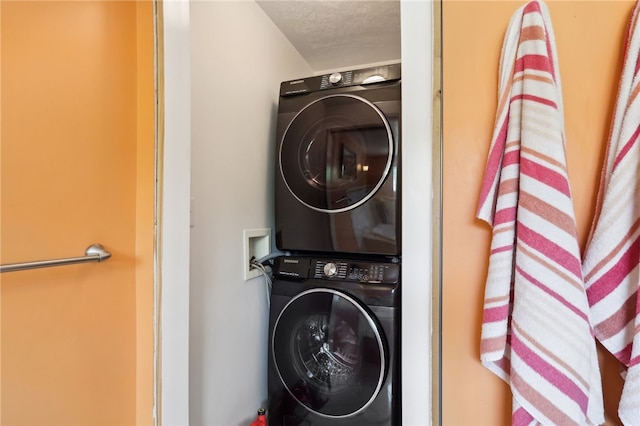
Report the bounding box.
[268,256,401,426]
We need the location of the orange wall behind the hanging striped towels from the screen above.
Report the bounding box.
[442,0,633,425]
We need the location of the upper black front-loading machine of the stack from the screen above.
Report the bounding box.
[275,64,401,256]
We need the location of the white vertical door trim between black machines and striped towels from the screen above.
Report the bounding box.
[400,0,437,426]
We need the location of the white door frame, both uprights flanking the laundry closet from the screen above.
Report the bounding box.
[155,0,441,425]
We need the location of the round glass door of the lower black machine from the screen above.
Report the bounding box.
[272,288,388,418]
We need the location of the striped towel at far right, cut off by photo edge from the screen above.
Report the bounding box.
[583,3,640,425]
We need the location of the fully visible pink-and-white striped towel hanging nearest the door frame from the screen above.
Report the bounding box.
[477,1,604,425]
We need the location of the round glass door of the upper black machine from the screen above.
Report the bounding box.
[279,94,394,213]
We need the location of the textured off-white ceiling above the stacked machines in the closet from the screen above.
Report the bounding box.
[256,0,400,71]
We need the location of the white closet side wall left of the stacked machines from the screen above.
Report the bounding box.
[189,1,311,426]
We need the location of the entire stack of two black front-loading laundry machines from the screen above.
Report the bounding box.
[268,64,401,426]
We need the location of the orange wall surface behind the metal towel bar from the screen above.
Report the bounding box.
[0,1,154,425]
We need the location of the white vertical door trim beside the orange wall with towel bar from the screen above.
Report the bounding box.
[161,0,191,426]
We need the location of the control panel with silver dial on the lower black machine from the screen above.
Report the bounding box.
[273,257,400,284]
